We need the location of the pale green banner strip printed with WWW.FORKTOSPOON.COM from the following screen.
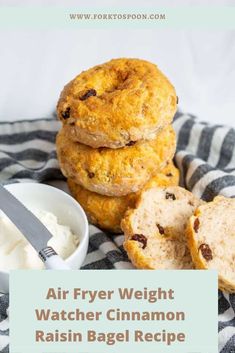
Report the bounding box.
[0,3,235,30]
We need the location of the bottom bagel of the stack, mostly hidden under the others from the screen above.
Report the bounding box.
[68,162,179,233]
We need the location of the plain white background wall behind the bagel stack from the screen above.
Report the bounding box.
[0,0,235,125]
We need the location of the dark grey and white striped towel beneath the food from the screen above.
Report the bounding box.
[0,113,235,353]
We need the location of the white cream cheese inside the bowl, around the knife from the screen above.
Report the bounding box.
[0,210,79,271]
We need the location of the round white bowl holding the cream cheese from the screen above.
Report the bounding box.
[0,183,89,293]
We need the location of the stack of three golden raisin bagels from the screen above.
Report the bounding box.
[56,59,179,233]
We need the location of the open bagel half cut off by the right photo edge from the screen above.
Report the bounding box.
[186,196,235,293]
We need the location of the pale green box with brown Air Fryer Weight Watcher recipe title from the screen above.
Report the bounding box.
[10,270,218,353]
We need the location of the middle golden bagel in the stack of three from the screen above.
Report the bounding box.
[56,126,176,196]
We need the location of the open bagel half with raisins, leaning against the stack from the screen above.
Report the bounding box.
[121,186,201,270]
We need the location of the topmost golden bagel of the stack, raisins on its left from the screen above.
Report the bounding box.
[57,58,177,148]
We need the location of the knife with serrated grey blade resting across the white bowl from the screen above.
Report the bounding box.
[0,185,69,269]
